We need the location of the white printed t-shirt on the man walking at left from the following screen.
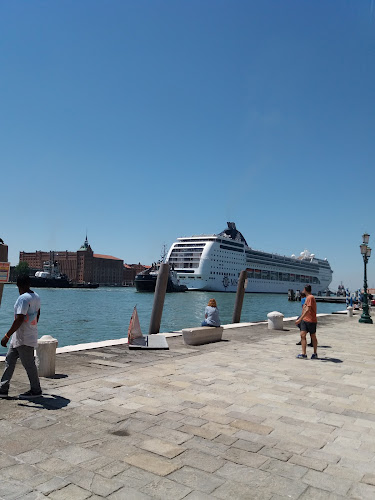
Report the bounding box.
[10,292,40,347]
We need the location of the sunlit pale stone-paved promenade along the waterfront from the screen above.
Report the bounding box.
[0,315,375,500]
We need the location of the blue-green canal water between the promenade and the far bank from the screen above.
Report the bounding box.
[0,285,344,355]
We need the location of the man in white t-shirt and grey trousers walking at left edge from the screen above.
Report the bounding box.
[0,275,42,399]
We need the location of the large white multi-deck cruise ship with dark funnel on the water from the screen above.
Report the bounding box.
[166,222,332,294]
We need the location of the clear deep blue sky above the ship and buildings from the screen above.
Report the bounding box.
[0,0,375,288]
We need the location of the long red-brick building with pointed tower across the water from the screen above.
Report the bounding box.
[20,236,124,286]
